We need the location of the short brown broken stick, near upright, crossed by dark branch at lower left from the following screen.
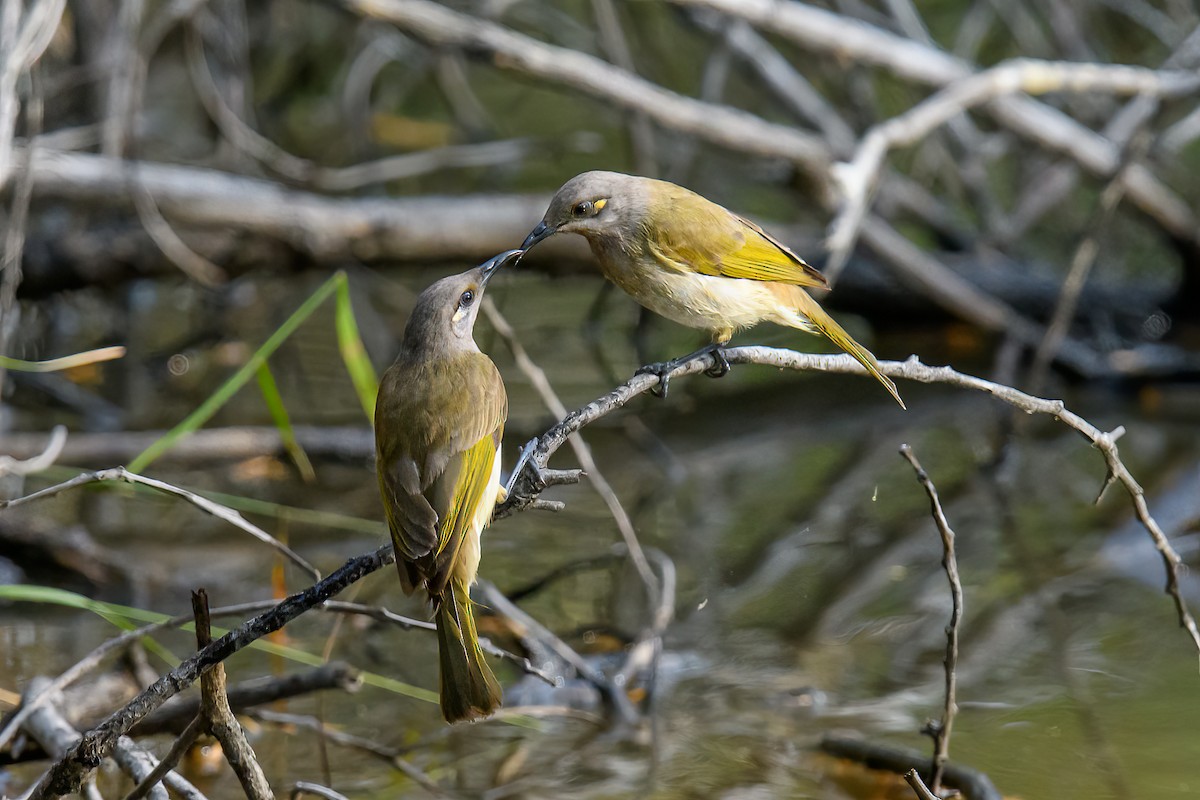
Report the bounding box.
[192,589,275,800]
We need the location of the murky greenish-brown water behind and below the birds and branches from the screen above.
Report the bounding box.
[0,263,1200,800]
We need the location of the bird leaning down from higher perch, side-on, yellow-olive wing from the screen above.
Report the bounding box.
[521,172,904,408]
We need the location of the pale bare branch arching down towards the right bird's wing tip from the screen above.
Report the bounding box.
[824,59,1200,281]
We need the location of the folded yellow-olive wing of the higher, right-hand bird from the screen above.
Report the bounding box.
[646,187,829,287]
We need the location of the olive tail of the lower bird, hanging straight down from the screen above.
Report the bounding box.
[436,578,500,722]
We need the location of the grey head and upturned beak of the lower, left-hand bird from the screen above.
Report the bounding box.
[403,249,524,354]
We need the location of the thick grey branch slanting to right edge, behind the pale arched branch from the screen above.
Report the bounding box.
[671,0,1200,242]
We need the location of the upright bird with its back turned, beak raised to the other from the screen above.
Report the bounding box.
[376,251,521,722]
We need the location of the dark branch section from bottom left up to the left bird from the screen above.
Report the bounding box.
[30,545,395,800]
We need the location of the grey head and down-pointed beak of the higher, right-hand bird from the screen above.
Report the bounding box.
[521,172,647,249]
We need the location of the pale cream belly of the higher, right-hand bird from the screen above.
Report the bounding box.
[601,257,803,332]
